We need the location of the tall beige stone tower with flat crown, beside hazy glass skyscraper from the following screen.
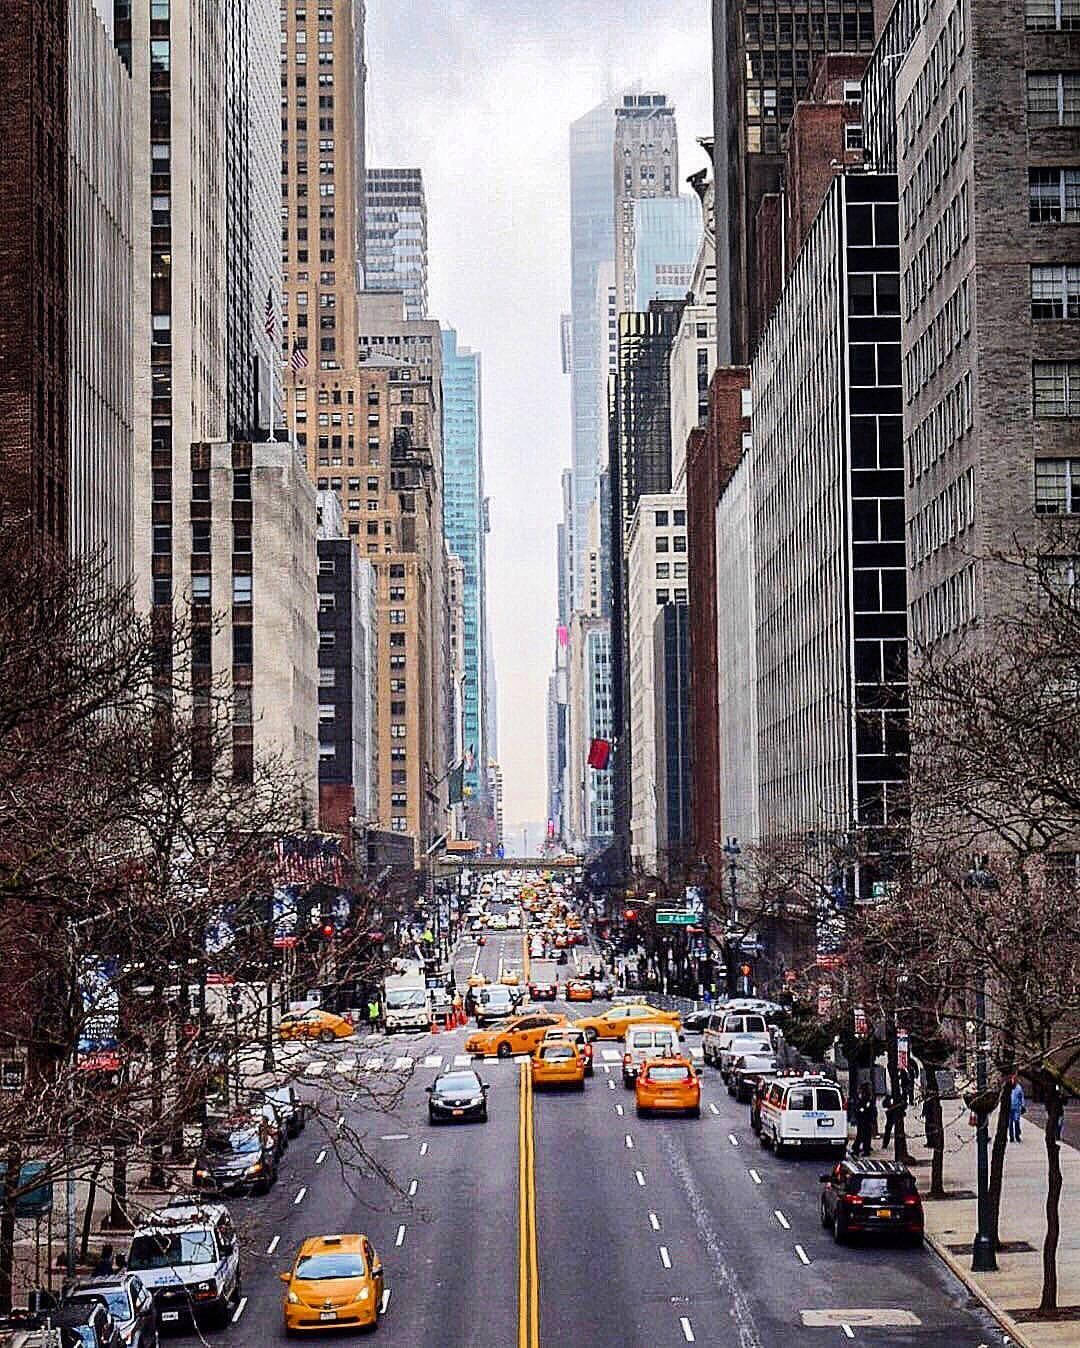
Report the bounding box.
[612,93,678,313]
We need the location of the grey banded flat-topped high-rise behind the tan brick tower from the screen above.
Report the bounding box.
[363,169,427,318]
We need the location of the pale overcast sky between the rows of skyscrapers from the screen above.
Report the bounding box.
[367,0,712,829]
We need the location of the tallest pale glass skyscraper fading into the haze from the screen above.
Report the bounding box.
[569,101,615,605]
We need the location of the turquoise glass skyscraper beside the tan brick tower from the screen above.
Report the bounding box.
[442,328,488,798]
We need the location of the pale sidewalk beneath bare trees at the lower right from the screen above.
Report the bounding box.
[872,1100,1080,1348]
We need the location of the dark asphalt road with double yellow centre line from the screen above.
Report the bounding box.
[153,895,1003,1348]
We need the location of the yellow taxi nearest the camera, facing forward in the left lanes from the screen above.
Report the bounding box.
[280,1235,386,1335]
